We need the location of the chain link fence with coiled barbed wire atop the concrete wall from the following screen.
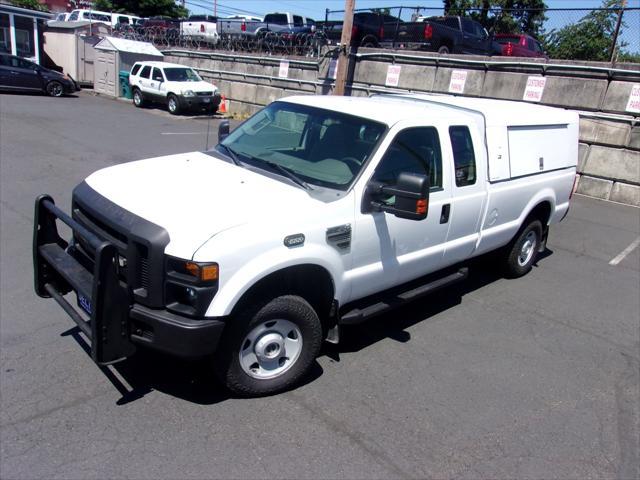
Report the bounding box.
[113,6,640,63]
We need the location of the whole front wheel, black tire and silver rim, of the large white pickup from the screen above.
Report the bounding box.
[214,295,322,397]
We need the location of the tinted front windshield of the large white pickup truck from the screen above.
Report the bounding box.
[218,102,386,190]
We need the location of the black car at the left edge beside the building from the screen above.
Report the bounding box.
[0,53,80,97]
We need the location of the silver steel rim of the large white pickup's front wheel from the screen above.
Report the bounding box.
[239,319,302,380]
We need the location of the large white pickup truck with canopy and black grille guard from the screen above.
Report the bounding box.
[33,95,578,396]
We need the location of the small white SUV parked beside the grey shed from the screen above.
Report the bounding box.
[129,62,221,115]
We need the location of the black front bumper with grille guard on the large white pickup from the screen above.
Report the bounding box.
[33,195,225,365]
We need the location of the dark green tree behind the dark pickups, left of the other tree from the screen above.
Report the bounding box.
[444,0,547,37]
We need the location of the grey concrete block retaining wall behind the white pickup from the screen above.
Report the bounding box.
[164,51,640,206]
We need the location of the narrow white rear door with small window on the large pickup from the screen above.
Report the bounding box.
[443,125,487,264]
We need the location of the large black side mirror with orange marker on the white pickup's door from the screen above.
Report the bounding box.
[362,172,430,220]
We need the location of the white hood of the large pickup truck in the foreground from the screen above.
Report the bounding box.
[86,152,323,258]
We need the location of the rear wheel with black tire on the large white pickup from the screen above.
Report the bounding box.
[502,220,542,278]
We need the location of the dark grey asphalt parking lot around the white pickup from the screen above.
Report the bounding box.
[0,92,640,479]
